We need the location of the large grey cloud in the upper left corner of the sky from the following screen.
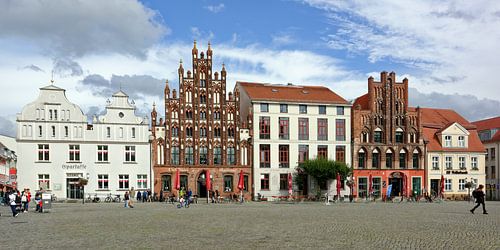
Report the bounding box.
[0,0,168,57]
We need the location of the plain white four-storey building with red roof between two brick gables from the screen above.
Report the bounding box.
[236,82,351,199]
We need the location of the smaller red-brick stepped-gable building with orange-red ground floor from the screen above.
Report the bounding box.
[351,72,425,197]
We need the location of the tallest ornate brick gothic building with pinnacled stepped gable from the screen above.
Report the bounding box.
[151,41,252,199]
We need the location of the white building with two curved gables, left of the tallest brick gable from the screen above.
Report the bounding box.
[17,85,151,199]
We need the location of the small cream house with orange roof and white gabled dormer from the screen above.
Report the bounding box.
[421,108,485,200]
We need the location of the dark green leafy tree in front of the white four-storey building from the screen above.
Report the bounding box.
[297,158,351,190]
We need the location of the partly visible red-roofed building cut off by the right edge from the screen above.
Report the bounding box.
[472,116,500,200]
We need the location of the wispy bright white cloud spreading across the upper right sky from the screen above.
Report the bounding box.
[305,0,500,100]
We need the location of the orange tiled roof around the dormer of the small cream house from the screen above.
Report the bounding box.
[421,108,485,153]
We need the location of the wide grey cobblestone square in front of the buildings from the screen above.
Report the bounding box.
[0,202,500,249]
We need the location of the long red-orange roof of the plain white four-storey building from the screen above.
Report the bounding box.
[236,82,349,104]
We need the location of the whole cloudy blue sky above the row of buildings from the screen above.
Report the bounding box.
[0,0,500,135]
